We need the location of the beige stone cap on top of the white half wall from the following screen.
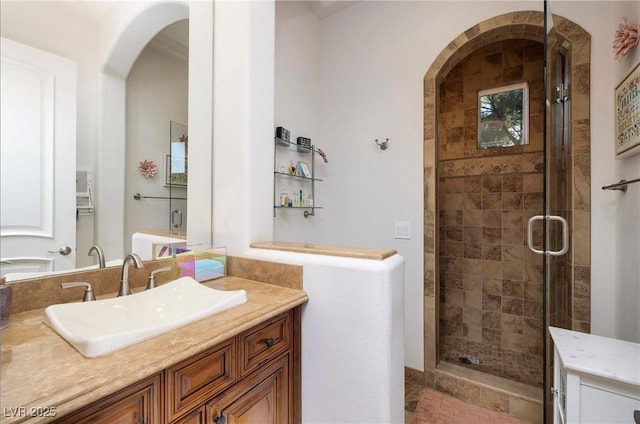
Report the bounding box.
[251,242,397,261]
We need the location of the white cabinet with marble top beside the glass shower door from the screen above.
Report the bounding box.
[549,327,640,424]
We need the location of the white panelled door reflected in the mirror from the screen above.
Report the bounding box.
[0,38,76,275]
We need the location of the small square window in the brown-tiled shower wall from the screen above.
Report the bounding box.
[478,82,529,149]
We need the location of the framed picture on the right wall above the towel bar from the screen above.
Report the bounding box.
[615,63,640,159]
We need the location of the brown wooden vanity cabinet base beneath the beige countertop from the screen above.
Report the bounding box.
[51,307,301,424]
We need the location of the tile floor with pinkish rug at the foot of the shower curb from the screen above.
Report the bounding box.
[405,369,524,424]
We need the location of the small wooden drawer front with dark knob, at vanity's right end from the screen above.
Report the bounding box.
[238,313,291,376]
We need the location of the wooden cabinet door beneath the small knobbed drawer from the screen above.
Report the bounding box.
[207,355,290,424]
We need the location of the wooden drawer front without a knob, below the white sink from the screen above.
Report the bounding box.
[166,338,236,421]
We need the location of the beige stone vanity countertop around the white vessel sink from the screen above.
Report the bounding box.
[0,277,308,424]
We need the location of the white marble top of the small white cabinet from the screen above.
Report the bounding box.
[549,327,640,390]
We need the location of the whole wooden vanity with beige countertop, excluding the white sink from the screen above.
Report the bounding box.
[0,277,308,424]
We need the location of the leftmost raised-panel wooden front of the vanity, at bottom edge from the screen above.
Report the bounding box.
[55,374,164,424]
